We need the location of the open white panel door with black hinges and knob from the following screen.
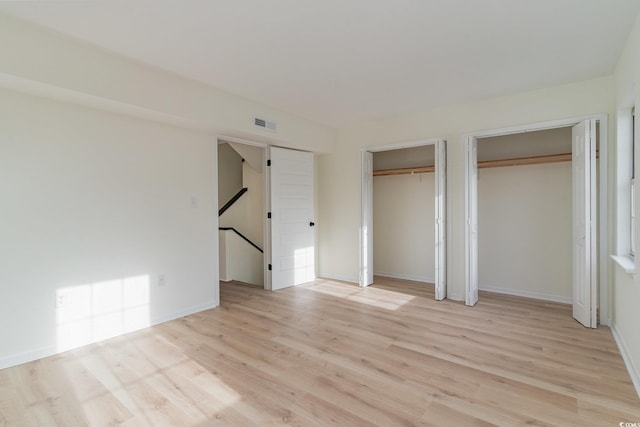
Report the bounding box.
[269,147,315,291]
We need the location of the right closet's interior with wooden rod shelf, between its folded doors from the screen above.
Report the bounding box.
[478,127,573,304]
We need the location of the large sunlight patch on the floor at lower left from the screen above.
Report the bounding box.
[65,334,241,426]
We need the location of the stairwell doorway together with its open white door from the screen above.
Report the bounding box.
[217,137,316,298]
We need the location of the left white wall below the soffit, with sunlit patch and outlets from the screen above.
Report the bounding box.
[0,90,218,367]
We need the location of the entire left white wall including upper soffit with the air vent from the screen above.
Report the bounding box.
[0,15,335,367]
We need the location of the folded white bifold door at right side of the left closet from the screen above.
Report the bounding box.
[435,140,447,301]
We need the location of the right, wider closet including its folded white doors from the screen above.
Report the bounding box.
[465,117,608,327]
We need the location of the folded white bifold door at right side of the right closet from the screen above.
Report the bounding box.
[572,120,597,328]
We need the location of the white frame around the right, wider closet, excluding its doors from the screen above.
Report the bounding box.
[462,114,611,325]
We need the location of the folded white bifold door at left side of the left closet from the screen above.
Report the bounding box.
[360,151,373,286]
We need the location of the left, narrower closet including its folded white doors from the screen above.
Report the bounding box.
[360,140,446,300]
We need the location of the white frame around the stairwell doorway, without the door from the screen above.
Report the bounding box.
[214,135,271,290]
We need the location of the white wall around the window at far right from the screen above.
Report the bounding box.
[611,10,640,395]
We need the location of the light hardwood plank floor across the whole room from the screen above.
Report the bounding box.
[0,278,640,426]
